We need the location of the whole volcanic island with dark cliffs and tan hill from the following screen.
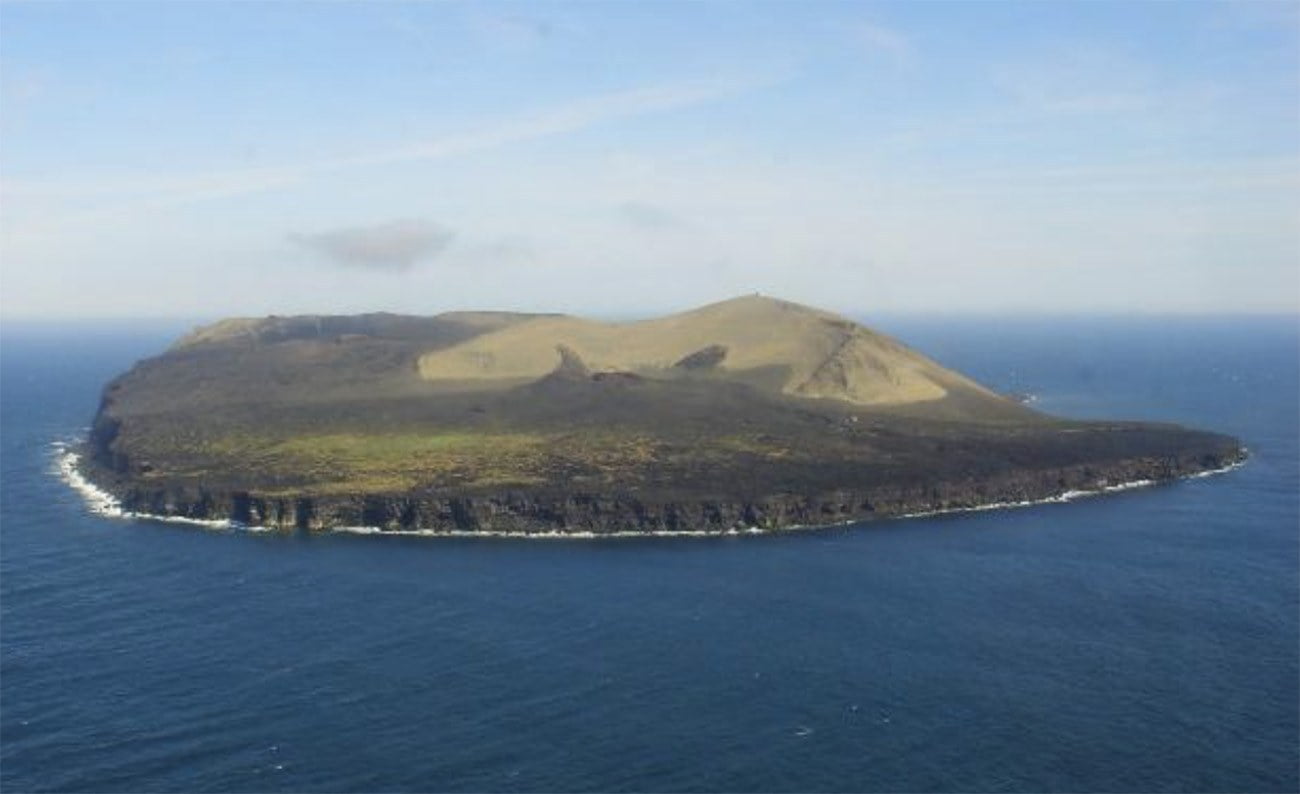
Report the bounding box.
[77,295,1245,535]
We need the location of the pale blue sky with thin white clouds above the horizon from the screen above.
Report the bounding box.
[0,1,1300,317]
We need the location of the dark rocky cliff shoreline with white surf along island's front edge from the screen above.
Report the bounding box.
[60,447,1245,537]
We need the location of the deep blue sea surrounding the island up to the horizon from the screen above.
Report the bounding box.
[0,318,1300,791]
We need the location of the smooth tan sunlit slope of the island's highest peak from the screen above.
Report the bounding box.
[419,295,1009,405]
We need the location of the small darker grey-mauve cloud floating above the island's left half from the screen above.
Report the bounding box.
[289,220,455,272]
